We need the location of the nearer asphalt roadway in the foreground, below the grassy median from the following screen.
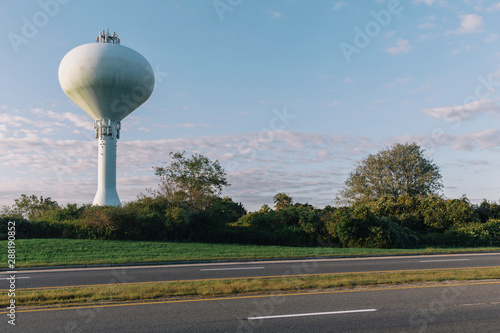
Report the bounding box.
[0,281,500,333]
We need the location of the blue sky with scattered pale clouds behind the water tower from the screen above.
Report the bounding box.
[0,0,500,210]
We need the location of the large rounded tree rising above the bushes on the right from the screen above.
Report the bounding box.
[337,143,443,204]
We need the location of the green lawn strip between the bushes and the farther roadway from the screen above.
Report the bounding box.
[0,239,500,268]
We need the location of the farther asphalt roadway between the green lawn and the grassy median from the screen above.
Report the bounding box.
[0,253,500,290]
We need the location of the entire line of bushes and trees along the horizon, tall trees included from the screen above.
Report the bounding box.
[0,143,500,248]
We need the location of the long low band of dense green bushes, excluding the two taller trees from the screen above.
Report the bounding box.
[0,196,500,248]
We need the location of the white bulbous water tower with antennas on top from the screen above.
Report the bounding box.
[59,29,155,206]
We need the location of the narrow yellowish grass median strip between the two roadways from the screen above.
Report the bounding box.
[0,268,500,308]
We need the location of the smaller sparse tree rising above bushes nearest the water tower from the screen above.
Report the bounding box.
[153,152,230,210]
